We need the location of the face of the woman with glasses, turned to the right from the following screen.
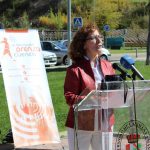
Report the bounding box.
[84,30,103,57]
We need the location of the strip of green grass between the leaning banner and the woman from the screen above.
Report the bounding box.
[47,71,68,131]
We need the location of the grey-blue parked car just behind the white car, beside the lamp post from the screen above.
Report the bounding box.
[41,41,69,65]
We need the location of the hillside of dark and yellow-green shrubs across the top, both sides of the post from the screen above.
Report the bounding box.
[0,0,148,30]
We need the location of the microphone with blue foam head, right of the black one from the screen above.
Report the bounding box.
[120,55,144,80]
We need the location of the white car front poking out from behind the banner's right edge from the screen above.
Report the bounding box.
[42,50,57,67]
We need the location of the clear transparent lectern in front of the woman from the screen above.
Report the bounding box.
[74,80,150,150]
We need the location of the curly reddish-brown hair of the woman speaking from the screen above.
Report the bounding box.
[69,23,99,62]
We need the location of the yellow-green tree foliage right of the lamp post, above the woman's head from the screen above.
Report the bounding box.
[60,0,121,29]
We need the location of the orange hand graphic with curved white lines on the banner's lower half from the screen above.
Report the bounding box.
[12,85,56,145]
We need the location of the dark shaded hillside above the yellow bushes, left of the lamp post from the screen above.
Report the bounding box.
[0,0,61,19]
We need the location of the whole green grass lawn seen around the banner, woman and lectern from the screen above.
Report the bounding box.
[0,62,150,140]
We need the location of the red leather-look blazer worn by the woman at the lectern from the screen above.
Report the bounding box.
[64,59,115,130]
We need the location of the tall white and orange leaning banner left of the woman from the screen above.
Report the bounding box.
[0,30,60,147]
